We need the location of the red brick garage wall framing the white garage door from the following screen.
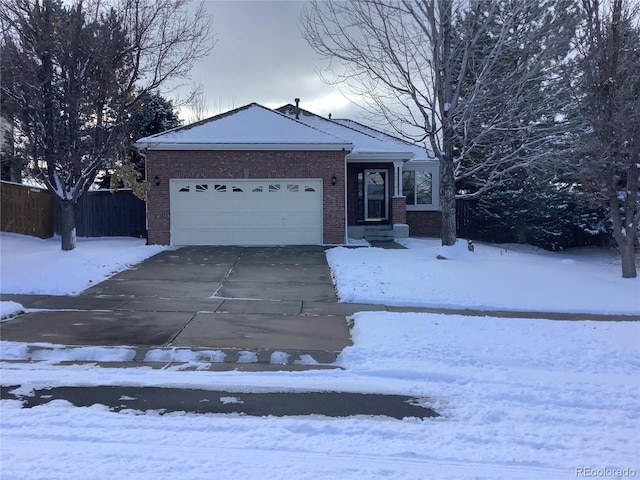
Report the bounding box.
[146,150,345,245]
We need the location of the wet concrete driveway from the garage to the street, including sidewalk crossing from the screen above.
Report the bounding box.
[0,246,368,370]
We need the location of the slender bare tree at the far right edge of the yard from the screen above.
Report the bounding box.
[577,0,640,278]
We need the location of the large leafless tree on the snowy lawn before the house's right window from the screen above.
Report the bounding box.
[302,0,577,245]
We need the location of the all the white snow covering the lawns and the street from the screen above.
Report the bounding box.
[0,234,640,480]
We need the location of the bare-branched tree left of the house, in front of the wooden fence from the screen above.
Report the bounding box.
[0,0,212,250]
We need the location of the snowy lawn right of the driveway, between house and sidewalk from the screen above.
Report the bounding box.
[327,238,640,314]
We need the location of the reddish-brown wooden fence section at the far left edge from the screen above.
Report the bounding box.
[0,181,55,238]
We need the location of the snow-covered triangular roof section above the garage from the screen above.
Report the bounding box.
[136,103,353,151]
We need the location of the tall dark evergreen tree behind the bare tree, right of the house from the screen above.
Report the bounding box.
[455,0,596,250]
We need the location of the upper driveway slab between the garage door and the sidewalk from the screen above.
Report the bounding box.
[83,246,337,302]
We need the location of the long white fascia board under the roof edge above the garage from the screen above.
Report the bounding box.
[135,142,353,152]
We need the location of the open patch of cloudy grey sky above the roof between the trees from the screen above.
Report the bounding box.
[175,0,358,124]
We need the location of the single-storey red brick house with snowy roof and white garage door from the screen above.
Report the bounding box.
[136,103,441,245]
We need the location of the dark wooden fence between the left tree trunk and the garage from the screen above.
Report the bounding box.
[55,190,146,238]
